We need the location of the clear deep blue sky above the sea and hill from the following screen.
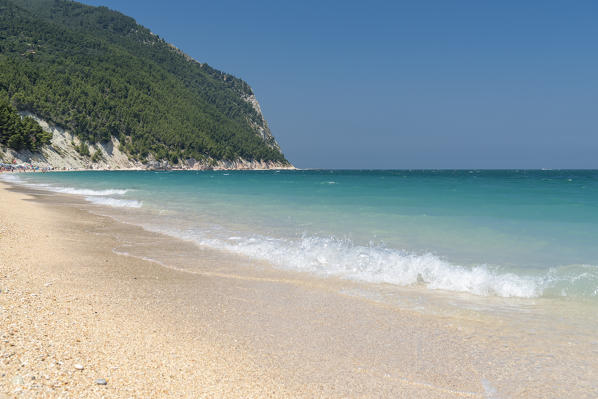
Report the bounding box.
[84,0,598,168]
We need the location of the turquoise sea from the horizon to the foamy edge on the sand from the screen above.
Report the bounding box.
[2,170,598,301]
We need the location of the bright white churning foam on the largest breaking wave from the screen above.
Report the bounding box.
[225,237,540,297]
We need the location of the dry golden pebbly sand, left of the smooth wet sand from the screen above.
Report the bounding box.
[0,183,312,398]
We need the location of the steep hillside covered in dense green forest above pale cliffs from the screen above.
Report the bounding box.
[0,0,287,163]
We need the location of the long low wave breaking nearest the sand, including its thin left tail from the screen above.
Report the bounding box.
[139,226,576,298]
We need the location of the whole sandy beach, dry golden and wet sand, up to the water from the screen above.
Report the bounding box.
[0,183,598,398]
